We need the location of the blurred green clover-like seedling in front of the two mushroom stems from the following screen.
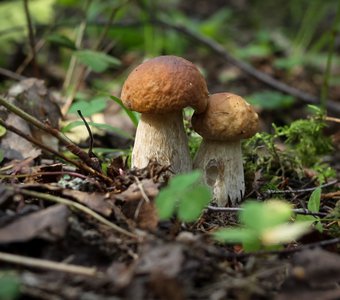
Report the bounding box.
[156,171,211,222]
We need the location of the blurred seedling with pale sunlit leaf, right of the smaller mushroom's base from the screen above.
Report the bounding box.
[213,199,311,252]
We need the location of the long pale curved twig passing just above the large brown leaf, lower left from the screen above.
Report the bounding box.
[2,185,138,239]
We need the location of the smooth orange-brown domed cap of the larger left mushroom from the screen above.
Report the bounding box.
[121,56,208,114]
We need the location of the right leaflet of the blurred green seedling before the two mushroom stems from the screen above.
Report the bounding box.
[177,185,211,222]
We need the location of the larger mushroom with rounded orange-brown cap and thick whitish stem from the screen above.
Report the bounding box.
[121,56,209,174]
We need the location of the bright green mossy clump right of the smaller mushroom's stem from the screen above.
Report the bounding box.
[244,108,335,183]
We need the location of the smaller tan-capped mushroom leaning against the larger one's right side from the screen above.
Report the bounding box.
[192,93,259,206]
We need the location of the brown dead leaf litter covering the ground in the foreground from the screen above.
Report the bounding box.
[0,81,340,300]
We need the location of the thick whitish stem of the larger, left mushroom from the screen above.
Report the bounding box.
[132,112,192,174]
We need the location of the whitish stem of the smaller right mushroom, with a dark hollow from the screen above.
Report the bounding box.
[194,140,245,206]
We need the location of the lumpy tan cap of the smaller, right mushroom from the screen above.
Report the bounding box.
[191,93,259,141]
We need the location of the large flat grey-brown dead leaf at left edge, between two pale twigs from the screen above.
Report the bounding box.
[0,204,70,243]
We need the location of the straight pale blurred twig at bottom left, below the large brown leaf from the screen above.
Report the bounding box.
[0,252,100,276]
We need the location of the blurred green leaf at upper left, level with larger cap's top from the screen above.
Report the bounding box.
[74,50,120,73]
